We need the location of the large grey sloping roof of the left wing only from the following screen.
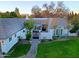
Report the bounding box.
[0,18,25,39]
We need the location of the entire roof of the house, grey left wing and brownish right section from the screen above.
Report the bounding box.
[0,18,67,39]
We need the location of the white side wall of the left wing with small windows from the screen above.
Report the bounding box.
[1,29,26,53]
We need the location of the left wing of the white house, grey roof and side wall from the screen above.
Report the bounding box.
[0,18,25,53]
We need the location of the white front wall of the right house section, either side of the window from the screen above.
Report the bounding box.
[40,29,69,39]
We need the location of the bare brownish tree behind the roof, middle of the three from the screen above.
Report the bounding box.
[42,2,55,17]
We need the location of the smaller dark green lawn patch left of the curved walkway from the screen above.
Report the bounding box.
[5,43,30,58]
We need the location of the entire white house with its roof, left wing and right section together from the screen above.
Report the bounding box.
[0,18,68,53]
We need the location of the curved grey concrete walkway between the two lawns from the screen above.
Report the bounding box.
[22,39,40,58]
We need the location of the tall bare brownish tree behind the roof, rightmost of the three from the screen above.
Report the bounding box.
[56,1,69,17]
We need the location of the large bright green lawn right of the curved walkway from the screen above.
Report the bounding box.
[36,37,79,58]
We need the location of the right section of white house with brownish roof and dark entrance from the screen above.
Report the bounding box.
[33,18,68,39]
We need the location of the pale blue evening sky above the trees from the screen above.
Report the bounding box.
[0,1,79,14]
